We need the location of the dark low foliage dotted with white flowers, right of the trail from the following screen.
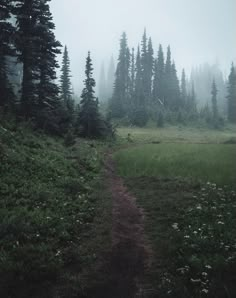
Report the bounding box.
[126,177,236,298]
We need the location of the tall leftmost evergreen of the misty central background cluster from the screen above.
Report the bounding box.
[110,32,130,118]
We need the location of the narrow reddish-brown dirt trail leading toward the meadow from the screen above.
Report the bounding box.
[105,153,151,298]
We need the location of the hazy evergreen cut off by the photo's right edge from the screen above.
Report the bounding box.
[227,64,236,123]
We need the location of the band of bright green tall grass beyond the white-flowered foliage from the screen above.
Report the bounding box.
[114,144,236,185]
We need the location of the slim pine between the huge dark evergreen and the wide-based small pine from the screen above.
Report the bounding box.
[60,46,73,110]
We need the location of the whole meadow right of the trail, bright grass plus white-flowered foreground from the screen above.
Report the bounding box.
[114,127,236,298]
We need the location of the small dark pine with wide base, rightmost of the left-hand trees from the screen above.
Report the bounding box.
[79,52,105,138]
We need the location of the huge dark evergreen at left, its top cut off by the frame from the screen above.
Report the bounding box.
[14,0,61,121]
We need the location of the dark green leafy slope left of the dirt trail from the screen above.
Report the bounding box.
[0,125,111,297]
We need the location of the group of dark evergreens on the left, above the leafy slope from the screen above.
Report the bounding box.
[0,0,111,137]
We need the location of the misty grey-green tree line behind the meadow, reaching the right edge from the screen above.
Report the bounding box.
[109,30,236,127]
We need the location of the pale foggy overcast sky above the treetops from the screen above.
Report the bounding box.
[51,0,236,92]
